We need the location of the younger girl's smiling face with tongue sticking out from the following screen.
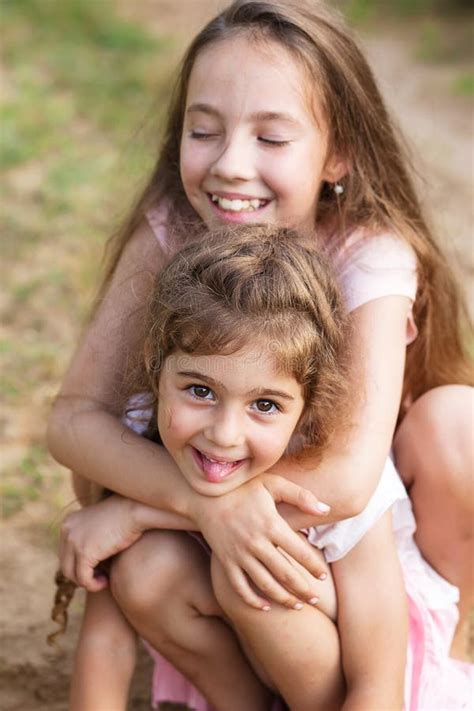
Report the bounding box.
[158,347,304,496]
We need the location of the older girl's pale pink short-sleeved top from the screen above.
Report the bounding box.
[146,205,418,345]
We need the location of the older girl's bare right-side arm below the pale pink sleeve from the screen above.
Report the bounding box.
[274,296,410,527]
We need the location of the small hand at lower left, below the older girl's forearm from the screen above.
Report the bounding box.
[59,495,144,592]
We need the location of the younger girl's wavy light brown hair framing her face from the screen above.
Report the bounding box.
[50,226,348,640]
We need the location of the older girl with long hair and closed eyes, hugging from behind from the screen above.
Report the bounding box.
[49,0,472,696]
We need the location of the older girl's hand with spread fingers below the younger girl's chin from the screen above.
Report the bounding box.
[192,474,329,609]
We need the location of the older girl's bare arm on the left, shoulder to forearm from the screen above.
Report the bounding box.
[48,218,187,513]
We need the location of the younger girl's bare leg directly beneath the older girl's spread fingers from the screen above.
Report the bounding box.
[212,556,345,711]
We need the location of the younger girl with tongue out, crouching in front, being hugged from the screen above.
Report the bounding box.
[66,228,412,711]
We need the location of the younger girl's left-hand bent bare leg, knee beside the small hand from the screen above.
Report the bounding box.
[111,531,270,711]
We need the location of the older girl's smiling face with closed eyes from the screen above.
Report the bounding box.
[180,36,341,234]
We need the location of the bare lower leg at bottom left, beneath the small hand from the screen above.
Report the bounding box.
[69,590,136,711]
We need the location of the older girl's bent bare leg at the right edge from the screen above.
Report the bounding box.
[394,385,474,659]
